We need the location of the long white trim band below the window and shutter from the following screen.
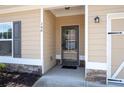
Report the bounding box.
[0,57,42,66]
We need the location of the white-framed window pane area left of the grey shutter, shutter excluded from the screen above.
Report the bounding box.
[0,22,13,56]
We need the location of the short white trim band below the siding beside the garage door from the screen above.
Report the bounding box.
[86,62,107,70]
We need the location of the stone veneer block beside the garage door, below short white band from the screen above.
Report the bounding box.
[86,69,107,84]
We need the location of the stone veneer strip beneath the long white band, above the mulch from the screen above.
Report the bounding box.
[1,63,42,75]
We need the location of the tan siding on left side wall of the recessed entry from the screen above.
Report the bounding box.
[43,10,56,72]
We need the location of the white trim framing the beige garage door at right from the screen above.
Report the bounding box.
[106,12,124,83]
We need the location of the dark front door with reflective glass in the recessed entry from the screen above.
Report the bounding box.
[61,25,79,66]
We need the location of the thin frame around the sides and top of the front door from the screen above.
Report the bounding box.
[60,24,80,65]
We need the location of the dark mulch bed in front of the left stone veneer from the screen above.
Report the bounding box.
[0,72,41,87]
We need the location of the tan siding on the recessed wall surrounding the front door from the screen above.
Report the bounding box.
[56,15,85,55]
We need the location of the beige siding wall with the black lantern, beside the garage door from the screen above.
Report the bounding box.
[88,5,124,63]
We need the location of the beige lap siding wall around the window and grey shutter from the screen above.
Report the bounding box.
[0,10,40,59]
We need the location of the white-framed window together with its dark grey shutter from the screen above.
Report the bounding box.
[0,21,21,58]
